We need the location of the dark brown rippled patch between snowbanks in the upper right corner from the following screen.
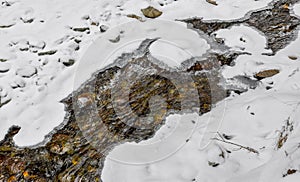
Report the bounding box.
[180,0,300,55]
